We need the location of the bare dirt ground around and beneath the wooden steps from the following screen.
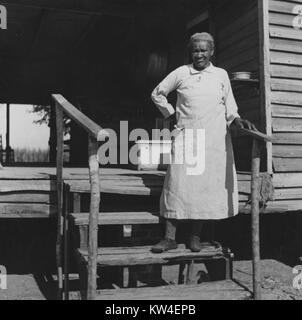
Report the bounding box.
[0,260,302,300]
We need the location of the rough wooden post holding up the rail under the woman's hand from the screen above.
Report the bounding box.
[251,139,261,300]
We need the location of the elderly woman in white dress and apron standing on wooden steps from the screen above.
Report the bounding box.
[152,33,256,253]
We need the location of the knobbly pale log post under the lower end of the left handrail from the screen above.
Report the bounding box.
[87,136,100,300]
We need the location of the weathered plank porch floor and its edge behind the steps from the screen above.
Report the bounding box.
[0,167,301,218]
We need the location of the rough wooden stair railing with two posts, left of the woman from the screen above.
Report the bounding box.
[52,94,109,299]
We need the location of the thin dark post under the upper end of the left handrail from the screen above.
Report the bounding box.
[56,104,64,300]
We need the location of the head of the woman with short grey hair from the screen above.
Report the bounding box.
[188,32,215,70]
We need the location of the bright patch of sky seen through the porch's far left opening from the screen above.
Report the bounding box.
[0,104,49,149]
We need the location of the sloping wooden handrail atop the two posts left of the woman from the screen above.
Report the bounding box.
[52,94,109,141]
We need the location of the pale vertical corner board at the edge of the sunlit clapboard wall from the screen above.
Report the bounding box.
[258,0,273,173]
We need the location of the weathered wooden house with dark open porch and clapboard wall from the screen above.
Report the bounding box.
[0,0,302,300]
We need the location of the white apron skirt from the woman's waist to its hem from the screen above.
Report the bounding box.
[160,116,238,220]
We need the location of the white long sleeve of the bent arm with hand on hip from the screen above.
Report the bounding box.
[151,69,178,118]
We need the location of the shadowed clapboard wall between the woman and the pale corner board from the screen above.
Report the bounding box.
[215,0,261,171]
